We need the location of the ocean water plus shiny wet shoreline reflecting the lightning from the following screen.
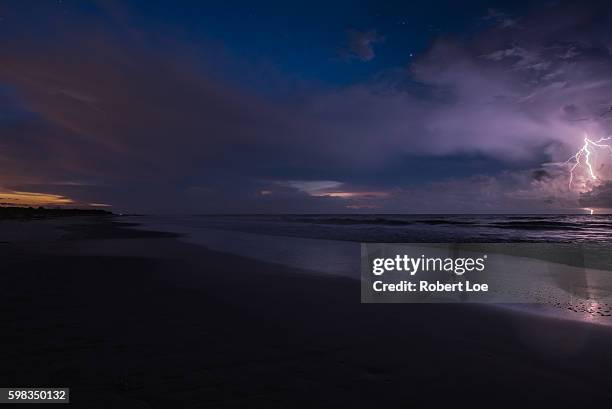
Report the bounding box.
[124,214,612,325]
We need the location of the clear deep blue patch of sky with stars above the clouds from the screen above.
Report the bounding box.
[113,1,524,87]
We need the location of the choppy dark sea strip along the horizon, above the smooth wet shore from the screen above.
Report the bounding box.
[151,214,612,243]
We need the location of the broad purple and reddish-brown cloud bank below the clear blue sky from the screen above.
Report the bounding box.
[0,3,612,212]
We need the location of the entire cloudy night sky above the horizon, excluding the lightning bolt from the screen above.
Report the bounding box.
[0,0,612,213]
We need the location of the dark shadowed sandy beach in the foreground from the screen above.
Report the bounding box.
[0,217,612,408]
